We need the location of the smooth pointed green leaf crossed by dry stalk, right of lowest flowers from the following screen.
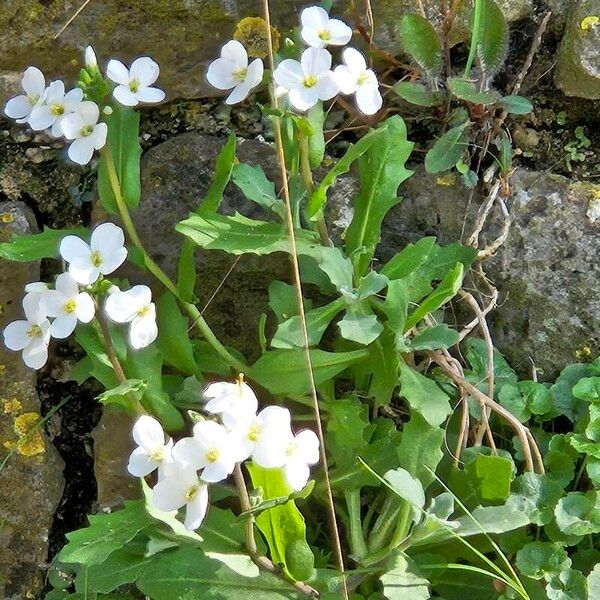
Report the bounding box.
[250,349,368,394]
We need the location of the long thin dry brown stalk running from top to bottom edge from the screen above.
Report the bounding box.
[263,0,348,600]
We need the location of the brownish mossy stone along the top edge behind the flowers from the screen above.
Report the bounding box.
[0,0,533,103]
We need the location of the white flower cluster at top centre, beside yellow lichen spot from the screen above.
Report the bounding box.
[207,6,383,115]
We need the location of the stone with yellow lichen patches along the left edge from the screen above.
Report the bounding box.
[0,202,64,600]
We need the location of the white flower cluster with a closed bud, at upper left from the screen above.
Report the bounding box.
[4,46,165,165]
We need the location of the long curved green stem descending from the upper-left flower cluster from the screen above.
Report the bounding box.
[101,146,248,373]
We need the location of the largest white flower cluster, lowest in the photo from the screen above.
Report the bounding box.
[128,375,319,530]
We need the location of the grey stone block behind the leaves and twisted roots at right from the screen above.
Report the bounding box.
[382,169,600,379]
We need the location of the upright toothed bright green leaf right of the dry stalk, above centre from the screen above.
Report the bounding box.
[345,115,414,276]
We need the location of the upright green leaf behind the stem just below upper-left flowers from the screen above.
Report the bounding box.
[98,103,142,214]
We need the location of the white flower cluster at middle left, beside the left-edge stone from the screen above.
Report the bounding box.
[4,223,158,369]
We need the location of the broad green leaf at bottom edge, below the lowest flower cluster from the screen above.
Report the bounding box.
[137,546,297,600]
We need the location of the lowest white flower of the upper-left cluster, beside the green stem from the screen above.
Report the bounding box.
[61,100,108,165]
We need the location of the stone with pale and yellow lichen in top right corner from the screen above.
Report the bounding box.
[554,0,600,99]
